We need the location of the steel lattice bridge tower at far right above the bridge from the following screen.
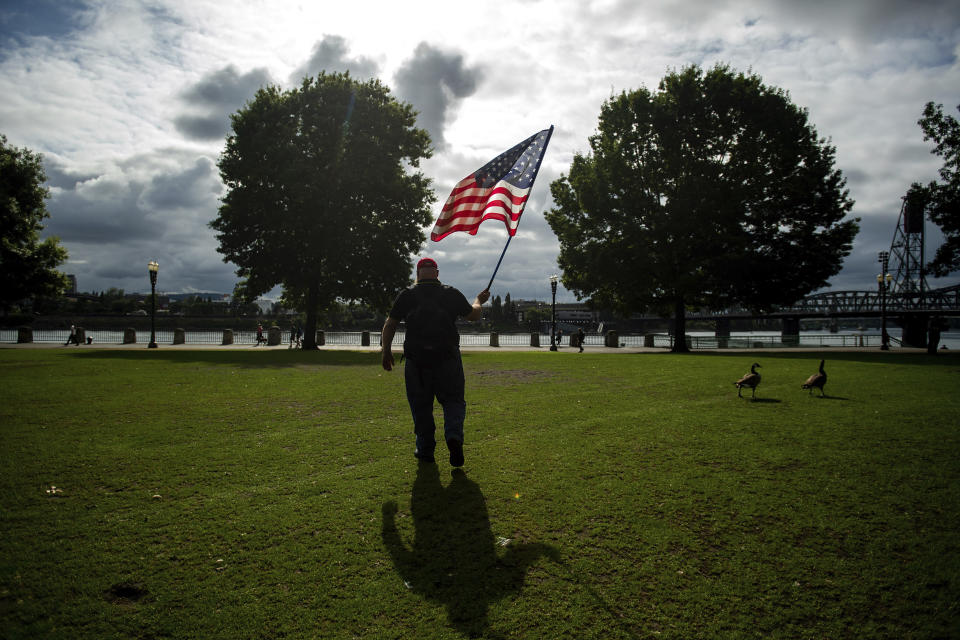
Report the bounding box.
[890,187,928,309]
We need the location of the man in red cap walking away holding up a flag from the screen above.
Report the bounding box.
[381,258,490,467]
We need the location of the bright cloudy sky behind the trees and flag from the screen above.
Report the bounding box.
[0,0,960,300]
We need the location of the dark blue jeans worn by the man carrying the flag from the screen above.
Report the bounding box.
[403,351,467,456]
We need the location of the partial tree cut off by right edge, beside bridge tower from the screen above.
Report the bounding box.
[911,102,960,276]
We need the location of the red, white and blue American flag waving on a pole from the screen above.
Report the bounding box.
[430,127,553,242]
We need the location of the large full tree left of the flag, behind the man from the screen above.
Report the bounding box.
[210,73,435,349]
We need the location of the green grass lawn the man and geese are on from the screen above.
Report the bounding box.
[0,349,960,639]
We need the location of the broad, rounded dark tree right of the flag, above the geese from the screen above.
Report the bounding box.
[546,66,858,351]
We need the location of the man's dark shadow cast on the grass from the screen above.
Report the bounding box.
[382,464,559,637]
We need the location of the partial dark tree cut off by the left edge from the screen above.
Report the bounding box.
[0,135,67,310]
